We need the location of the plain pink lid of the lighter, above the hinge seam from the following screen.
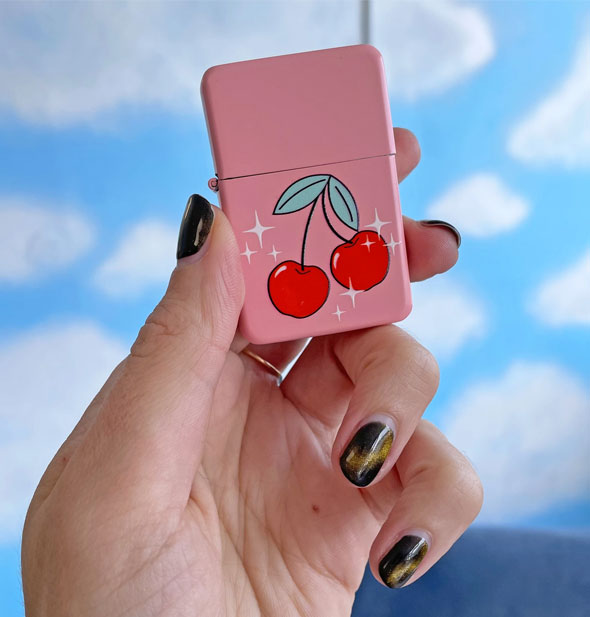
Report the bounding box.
[201,45,395,179]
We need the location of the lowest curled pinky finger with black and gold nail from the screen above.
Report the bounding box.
[369,420,483,588]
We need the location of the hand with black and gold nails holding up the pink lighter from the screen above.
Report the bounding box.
[22,130,481,617]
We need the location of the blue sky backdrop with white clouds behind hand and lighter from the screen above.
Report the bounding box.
[0,0,590,616]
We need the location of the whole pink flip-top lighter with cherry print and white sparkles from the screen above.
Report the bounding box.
[201,45,411,344]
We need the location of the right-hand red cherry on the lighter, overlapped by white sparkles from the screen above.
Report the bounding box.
[330,231,389,291]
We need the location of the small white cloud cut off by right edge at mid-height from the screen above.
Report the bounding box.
[529,251,590,326]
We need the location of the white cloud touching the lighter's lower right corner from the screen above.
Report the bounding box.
[401,277,488,358]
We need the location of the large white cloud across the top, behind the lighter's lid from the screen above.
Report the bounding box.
[0,0,494,126]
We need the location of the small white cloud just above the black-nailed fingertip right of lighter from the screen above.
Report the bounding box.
[426,173,530,237]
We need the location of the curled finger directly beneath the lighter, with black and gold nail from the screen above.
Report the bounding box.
[332,326,439,487]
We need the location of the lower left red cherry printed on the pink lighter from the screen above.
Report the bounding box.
[268,261,330,319]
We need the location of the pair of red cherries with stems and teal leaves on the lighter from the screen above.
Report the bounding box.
[268,174,389,320]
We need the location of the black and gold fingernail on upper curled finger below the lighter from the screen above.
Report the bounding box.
[340,422,393,486]
